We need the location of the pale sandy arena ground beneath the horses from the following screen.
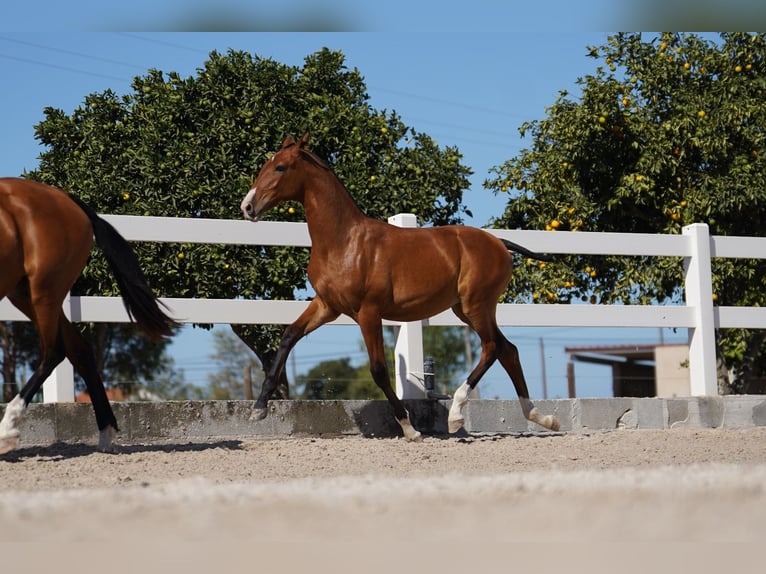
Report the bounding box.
[0,427,766,573]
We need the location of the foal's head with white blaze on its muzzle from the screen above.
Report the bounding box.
[241,132,309,221]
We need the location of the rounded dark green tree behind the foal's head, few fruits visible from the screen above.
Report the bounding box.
[28,49,471,396]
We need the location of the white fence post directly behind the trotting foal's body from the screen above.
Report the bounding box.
[388,213,426,399]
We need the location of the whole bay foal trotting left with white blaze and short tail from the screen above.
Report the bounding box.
[241,132,559,441]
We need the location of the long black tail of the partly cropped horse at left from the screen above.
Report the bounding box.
[69,195,177,340]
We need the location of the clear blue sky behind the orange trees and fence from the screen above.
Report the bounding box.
[0,31,685,398]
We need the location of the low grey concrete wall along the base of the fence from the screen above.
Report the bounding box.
[2,395,766,446]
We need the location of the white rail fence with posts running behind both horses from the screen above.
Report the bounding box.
[0,214,766,402]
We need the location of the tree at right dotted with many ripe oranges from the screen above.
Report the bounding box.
[485,33,766,392]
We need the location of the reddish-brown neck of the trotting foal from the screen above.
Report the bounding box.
[303,176,367,248]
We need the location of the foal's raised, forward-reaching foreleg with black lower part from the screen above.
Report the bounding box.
[250,297,340,420]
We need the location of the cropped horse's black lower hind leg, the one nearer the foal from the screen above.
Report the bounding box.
[59,313,119,452]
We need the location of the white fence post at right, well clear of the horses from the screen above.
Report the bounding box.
[683,223,718,396]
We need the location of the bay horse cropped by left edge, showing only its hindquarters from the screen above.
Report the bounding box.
[0,178,175,453]
